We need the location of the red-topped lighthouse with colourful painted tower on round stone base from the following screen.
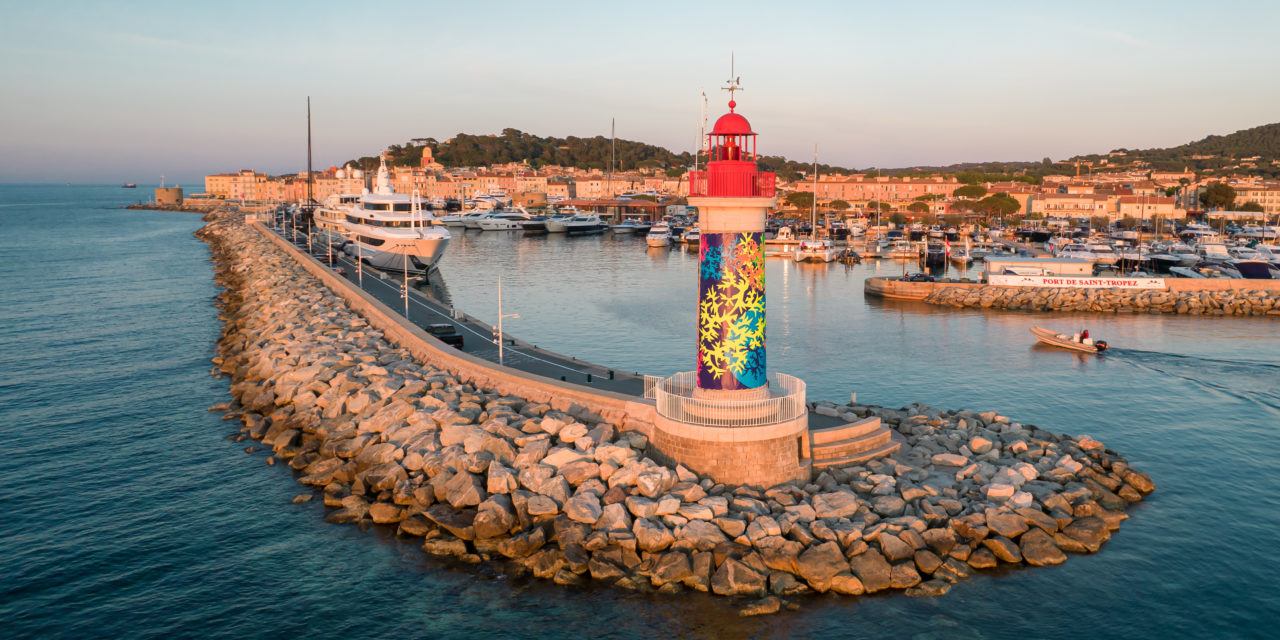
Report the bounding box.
[646,79,812,488]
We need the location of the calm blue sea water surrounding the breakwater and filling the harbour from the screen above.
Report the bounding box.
[0,186,1280,639]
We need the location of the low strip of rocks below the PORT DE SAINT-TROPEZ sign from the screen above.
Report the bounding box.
[924,285,1280,316]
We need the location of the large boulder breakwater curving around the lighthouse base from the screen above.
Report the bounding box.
[197,214,1153,614]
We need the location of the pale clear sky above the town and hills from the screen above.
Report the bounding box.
[0,0,1280,183]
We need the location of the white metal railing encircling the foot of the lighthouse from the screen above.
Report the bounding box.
[645,371,808,428]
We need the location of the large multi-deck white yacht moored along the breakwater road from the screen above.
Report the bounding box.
[344,160,452,273]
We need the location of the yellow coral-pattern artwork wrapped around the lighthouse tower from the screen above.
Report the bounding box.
[698,232,767,390]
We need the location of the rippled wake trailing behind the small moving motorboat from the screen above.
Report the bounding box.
[1107,348,1280,415]
